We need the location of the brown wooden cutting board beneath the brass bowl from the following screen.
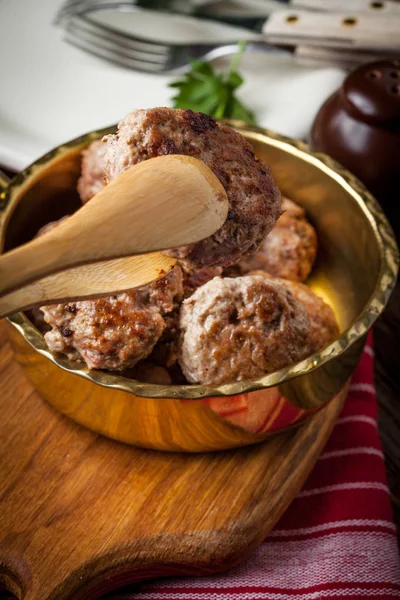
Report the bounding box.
[0,326,345,600]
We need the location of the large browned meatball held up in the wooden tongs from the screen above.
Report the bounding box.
[104,108,281,267]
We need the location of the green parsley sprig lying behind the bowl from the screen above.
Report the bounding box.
[169,42,255,123]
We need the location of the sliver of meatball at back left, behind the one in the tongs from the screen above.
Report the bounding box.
[77,140,106,204]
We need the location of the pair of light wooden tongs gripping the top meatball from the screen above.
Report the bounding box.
[0,155,228,317]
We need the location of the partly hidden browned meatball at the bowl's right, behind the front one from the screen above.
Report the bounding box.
[228,198,317,281]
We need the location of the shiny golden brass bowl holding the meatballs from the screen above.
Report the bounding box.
[0,122,398,452]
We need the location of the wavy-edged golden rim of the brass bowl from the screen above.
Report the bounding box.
[0,120,399,400]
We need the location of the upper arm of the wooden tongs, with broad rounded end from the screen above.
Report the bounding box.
[0,155,228,297]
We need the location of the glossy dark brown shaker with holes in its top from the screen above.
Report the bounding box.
[311,59,400,240]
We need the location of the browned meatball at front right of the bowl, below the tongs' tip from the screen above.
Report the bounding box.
[179,276,312,384]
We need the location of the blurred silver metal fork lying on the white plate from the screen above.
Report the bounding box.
[64,15,290,74]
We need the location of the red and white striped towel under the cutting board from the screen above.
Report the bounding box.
[107,332,400,600]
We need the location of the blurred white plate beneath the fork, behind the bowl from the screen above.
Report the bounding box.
[0,0,344,170]
